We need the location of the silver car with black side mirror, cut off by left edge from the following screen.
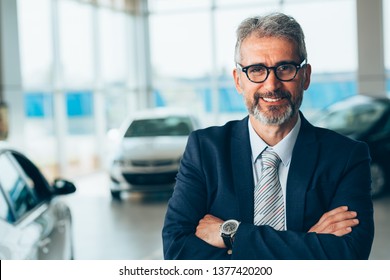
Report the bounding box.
[0,142,76,260]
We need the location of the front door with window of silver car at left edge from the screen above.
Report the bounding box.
[0,152,42,259]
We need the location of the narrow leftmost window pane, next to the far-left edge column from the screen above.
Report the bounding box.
[18,0,57,178]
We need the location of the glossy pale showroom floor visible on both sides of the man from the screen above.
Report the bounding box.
[64,173,390,260]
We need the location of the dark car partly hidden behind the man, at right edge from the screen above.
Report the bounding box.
[313,95,390,197]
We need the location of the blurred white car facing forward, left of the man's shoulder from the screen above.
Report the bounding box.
[110,109,199,199]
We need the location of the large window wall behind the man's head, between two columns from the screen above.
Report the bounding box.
[149,0,357,124]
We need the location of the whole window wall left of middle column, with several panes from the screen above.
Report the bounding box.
[18,0,138,177]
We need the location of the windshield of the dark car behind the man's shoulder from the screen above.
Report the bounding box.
[316,102,386,135]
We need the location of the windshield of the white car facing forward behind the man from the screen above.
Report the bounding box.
[125,116,193,137]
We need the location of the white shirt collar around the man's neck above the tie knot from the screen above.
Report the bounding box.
[248,114,301,166]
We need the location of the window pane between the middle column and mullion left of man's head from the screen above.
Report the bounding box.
[149,0,212,124]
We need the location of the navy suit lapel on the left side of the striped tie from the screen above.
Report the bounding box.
[231,117,254,223]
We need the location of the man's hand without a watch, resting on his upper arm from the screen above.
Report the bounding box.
[309,206,359,236]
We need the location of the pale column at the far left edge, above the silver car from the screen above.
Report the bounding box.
[0,0,25,149]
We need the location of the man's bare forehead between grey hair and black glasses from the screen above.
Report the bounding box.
[240,34,299,65]
